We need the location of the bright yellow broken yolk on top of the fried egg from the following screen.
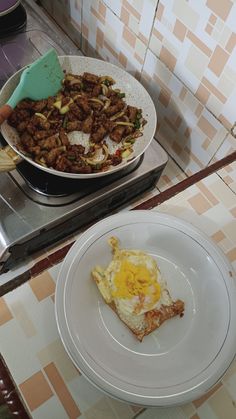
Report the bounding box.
[112,260,161,303]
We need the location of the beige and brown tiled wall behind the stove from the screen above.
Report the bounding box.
[41,0,236,175]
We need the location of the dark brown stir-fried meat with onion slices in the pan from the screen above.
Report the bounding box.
[8,72,146,173]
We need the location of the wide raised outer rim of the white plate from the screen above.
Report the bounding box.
[55,210,236,406]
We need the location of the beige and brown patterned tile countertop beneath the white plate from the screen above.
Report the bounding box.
[0,166,236,419]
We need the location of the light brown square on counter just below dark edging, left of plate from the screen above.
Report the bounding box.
[29,271,55,301]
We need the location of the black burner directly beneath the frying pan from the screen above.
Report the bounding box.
[17,156,143,197]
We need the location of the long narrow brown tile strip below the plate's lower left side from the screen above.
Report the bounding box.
[44,362,81,419]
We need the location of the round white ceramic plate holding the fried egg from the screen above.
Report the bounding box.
[55,211,236,406]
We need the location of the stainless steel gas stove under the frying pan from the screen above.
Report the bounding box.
[0,1,167,274]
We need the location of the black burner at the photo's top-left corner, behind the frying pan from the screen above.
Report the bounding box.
[0,4,27,38]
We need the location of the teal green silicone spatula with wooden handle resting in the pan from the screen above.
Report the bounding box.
[0,49,64,124]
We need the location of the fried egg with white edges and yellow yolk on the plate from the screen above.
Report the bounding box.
[92,237,172,315]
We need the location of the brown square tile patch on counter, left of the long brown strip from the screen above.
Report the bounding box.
[19,371,53,411]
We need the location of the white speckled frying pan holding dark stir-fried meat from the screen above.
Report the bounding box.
[0,56,157,179]
